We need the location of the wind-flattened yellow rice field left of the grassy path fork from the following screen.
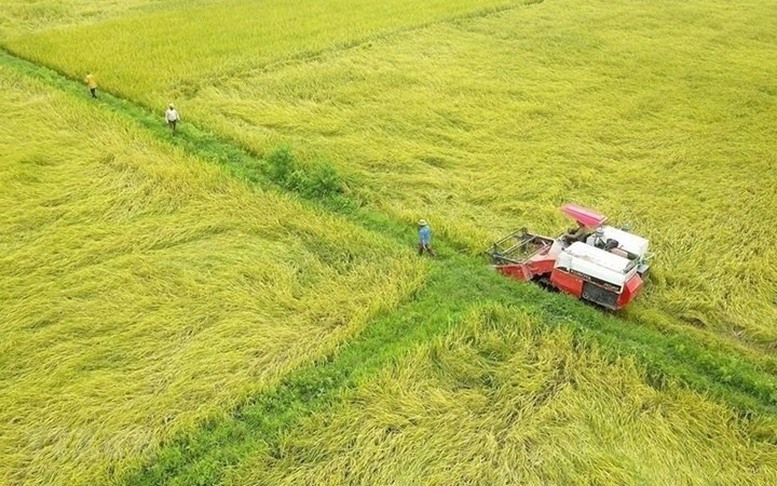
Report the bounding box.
[0,66,425,484]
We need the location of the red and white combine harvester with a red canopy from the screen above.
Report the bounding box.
[487,204,650,310]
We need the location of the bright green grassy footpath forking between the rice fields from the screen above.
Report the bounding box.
[0,45,777,484]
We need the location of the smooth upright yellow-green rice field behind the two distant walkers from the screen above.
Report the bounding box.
[0,0,523,106]
